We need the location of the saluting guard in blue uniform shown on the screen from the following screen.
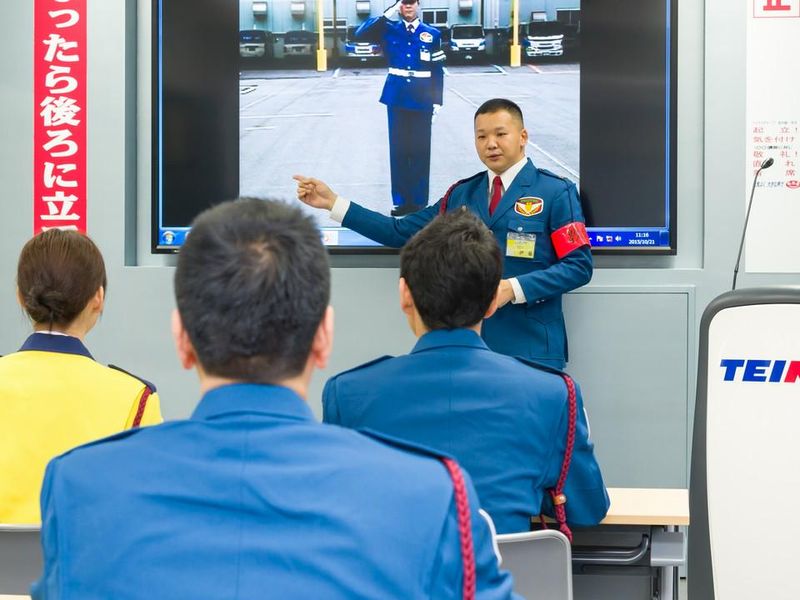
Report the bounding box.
[356,0,445,216]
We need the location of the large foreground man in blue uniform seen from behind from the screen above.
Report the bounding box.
[33,199,512,600]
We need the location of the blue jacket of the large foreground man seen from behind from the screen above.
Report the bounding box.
[33,384,512,600]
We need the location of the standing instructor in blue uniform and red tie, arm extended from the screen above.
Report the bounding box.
[295,98,592,369]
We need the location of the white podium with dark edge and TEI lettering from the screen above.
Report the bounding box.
[688,287,800,600]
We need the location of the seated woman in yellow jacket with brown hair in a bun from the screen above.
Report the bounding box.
[0,229,161,524]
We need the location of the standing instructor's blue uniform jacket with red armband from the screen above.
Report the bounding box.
[342,160,592,369]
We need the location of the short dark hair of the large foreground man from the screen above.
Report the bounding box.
[175,198,330,383]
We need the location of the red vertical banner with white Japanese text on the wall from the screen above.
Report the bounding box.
[33,0,87,234]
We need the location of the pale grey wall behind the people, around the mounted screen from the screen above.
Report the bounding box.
[0,0,800,486]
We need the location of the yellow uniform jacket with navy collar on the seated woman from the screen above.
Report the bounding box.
[0,333,162,524]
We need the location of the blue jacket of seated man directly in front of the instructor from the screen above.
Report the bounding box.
[323,329,609,533]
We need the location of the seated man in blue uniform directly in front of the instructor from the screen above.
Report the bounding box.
[323,210,609,533]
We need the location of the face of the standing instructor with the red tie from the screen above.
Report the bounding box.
[475,110,528,174]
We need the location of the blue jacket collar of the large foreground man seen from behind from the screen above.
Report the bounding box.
[192,383,314,420]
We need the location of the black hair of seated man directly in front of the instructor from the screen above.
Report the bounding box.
[400,209,503,329]
